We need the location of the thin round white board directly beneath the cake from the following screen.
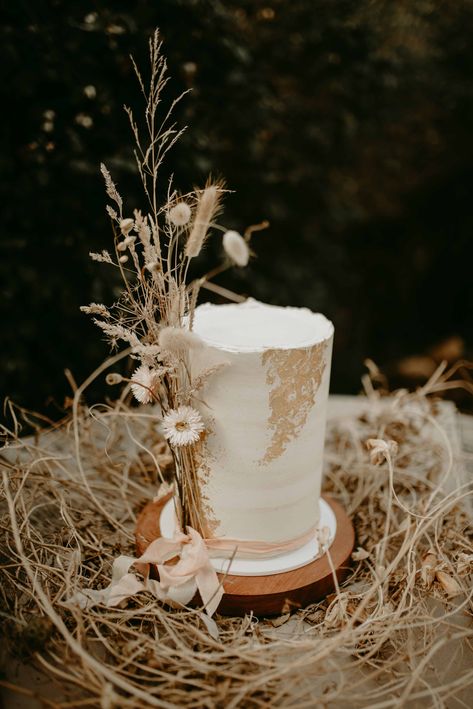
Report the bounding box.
[160,499,337,576]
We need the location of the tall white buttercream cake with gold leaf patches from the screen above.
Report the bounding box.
[191,300,333,544]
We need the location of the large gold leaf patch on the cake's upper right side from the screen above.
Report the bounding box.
[260,342,327,465]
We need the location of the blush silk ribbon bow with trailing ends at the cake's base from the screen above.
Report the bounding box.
[70,527,223,617]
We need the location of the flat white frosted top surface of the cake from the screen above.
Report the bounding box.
[194,298,333,352]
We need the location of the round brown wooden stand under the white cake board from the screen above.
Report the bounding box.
[135,495,355,616]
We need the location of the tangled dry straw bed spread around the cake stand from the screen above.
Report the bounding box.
[0,372,473,709]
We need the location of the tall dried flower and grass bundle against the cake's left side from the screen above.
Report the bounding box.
[82,31,267,534]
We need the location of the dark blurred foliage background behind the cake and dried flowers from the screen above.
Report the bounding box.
[0,0,473,419]
